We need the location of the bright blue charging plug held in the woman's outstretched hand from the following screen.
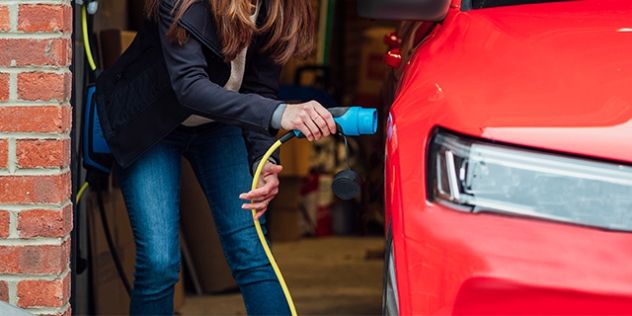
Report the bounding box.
[294,106,377,138]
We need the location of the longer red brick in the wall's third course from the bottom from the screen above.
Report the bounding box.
[18,205,72,238]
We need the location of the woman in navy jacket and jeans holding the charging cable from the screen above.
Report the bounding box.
[95,0,336,315]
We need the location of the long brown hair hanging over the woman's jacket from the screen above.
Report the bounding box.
[145,0,314,64]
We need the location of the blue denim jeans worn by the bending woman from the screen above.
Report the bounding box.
[117,123,290,315]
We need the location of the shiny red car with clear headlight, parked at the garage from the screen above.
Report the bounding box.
[358,0,632,315]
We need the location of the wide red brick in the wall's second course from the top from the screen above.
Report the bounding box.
[0,38,72,66]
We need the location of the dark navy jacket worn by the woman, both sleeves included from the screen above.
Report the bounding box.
[95,0,282,167]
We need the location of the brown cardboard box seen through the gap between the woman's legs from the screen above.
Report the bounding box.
[180,159,237,293]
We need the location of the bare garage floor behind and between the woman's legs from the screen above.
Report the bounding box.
[178,237,384,315]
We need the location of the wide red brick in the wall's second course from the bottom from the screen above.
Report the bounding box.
[0,241,70,274]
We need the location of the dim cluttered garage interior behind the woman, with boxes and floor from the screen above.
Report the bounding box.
[72,0,398,315]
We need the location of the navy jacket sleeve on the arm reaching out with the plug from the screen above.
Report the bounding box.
[158,0,281,135]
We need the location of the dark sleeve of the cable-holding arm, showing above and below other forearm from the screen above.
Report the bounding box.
[240,44,281,172]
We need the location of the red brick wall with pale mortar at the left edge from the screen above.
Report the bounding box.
[0,0,72,315]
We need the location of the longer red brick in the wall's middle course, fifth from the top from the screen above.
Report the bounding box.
[15,138,70,168]
